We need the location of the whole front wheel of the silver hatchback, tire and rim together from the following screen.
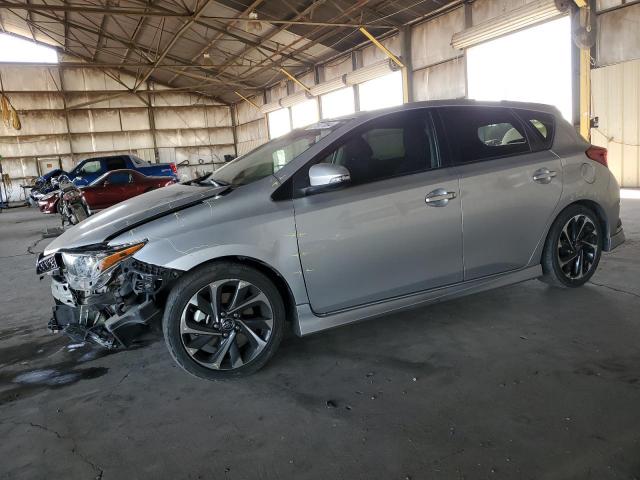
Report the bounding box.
[162,262,286,380]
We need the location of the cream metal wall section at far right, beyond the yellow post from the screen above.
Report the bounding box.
[591,0,640,187]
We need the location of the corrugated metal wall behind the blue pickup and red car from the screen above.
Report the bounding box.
[0,59,235,201]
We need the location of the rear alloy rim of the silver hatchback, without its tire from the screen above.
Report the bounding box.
[558,214,599,280]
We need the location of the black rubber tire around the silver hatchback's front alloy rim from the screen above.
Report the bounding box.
[162,262,286,380]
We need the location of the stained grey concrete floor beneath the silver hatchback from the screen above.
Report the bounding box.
[0,198,640,480]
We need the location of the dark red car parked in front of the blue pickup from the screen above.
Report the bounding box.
[81,170,176,211]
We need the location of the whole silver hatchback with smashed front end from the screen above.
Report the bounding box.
[37,100,624,379]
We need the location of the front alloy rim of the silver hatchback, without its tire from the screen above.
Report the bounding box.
[180,279,273,370]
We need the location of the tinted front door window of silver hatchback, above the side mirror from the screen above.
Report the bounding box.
[322,110,438,184]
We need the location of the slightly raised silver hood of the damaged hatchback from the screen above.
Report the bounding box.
[45,184,229,255]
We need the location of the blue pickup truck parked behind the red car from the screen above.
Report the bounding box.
[38,155,178,187]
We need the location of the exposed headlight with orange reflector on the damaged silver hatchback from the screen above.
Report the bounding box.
[62,242,146,291]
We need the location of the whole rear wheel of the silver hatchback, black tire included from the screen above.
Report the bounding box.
[540,205,603,288]
